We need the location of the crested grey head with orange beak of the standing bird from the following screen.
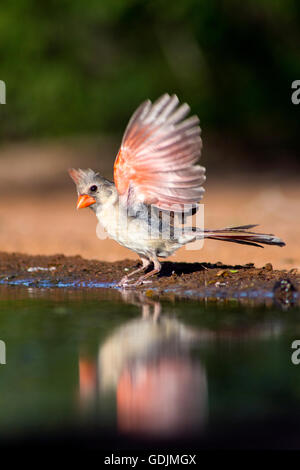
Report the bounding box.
[69,168,113,211]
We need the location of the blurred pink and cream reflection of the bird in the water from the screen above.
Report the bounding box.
[80,291,207,438]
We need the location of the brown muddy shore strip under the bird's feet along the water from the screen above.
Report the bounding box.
[0,253,300,306]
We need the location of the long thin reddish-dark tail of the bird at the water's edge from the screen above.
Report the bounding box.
[193,225,285,248]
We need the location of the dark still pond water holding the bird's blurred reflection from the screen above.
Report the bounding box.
[0,287,300,448]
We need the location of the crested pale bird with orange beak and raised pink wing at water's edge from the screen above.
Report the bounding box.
[68,93,285,288]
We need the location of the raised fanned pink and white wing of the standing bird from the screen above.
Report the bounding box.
[114,94,205,212]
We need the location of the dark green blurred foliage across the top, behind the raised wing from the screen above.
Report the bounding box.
[0,0,300,165]
